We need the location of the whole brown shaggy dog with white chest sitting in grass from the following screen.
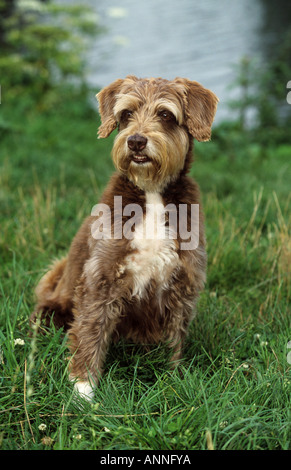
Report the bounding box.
[31,76,218,398]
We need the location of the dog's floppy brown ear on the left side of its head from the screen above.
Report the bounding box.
[96,78,123,139]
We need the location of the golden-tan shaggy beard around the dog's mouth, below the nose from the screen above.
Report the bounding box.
[112,131,189,192]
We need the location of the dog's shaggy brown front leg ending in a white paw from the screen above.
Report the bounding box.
[69,301,121,400]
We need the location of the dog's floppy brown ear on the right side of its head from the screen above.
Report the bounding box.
[175,78,219,142]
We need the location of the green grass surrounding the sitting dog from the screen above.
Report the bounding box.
[0,86,291,450]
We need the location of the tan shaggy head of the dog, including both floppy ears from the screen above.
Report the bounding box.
[97,76,218,191]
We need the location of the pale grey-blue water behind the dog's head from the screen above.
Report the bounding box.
[80,0,291,121]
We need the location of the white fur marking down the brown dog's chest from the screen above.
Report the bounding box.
[125,193,179,296]
